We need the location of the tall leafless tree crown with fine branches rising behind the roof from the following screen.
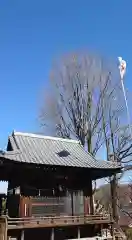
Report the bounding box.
[41,54,132,160]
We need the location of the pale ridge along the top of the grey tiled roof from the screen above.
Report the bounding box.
[13,131,80,143]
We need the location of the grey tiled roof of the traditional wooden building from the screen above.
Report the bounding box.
[0,132,120,169]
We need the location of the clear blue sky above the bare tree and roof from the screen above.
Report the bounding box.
[0,0,132,191]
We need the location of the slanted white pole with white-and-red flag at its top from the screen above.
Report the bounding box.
[118,57,132,139]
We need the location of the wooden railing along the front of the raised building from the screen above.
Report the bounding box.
[8,215,111,229]
